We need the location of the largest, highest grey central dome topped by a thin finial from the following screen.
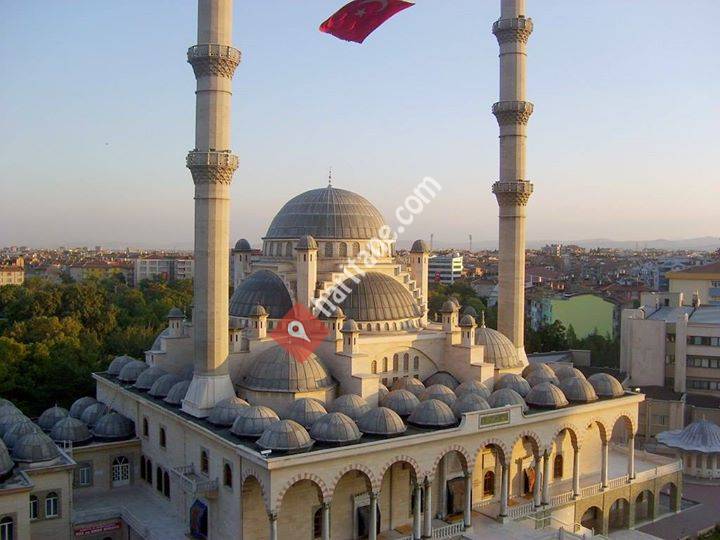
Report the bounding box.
[265,186,385,240]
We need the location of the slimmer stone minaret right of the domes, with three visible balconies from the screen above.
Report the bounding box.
[492,0,533,363]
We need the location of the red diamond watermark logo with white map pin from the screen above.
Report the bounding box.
[270,304,329,363]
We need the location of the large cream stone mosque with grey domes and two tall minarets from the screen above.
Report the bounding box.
[0,0,682,540]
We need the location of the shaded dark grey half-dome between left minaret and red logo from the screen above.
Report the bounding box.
[230,270,292,319]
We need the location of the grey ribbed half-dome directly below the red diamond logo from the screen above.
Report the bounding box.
[242,345,335,392]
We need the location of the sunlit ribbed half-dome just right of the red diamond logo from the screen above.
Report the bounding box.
[330,272,420,322]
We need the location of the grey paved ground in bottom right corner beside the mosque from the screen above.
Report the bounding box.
[639,483,720,540]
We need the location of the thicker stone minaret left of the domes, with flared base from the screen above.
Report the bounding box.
[182,0,240,417]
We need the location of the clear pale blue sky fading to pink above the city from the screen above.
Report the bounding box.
[0,0,720,247]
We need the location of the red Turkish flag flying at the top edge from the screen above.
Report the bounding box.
[320,0,415,43]
